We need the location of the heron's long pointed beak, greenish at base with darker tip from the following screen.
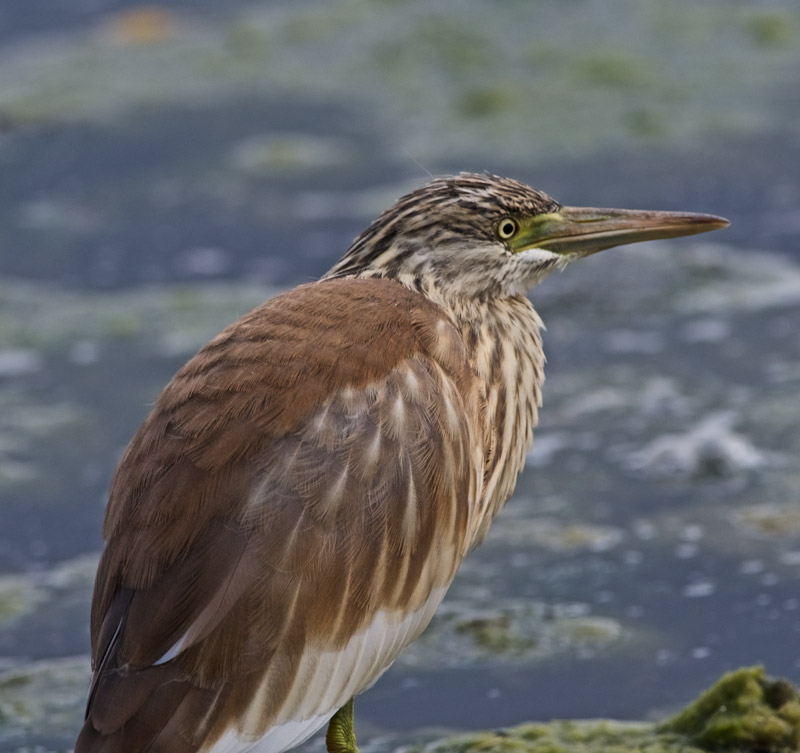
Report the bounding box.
[519,207,730,256]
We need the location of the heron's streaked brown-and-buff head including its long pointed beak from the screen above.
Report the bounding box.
[327,173,728,299]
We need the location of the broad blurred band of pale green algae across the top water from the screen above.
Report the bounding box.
[0,0,800,160]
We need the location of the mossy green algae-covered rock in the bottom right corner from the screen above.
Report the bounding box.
[412,667,800,753]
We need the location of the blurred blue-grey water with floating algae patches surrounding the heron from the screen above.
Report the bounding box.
[0,0,800,753]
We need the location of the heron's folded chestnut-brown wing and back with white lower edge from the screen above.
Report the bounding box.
[76,280,482,753]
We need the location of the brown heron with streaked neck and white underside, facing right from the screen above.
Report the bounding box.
[75,173,729,753]
